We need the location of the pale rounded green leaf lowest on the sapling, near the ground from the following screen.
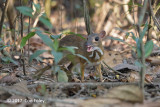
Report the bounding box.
[58,70,68,82]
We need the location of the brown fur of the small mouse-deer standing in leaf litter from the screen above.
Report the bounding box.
[59,31,105,82]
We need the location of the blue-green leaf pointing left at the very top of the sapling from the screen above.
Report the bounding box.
[16,6,33,17]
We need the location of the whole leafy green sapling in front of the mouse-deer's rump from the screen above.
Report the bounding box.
[17,4,89,82]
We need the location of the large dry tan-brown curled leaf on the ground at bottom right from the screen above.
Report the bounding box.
[106,85,143,103]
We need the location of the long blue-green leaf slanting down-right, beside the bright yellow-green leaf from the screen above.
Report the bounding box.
[36,31,53,49]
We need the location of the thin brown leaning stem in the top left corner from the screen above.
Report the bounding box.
[0,0,8,38]
